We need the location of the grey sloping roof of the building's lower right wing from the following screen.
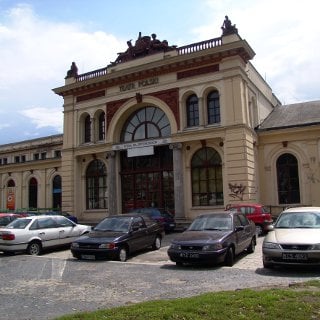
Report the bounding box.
[257,100,320,131]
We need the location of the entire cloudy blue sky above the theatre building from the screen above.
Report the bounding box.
[0,0,320,144]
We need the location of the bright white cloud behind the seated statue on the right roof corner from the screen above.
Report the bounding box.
[194,0,320,103]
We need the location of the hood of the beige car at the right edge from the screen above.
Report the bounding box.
[264,229,320,244]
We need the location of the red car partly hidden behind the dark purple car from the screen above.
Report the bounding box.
[227,203,273,236]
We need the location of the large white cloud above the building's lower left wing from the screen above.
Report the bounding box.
[0,5,126,142]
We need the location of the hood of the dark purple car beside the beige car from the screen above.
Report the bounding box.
[172,231,231,243]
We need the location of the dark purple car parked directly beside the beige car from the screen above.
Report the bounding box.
[168,211,256,266]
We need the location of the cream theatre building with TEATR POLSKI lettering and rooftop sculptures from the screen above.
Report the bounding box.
[0,20,320,222]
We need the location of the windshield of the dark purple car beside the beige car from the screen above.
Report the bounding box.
[188,215,232,231]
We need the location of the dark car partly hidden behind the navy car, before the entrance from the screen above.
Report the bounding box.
[130,207,176,233]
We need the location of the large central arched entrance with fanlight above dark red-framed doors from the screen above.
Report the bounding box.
[120,106,174,212]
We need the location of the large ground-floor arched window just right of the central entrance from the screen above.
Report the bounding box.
[191,147,223,206]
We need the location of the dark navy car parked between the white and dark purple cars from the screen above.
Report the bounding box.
[71,214,164,262]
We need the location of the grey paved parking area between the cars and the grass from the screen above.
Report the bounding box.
[0,234,320,320]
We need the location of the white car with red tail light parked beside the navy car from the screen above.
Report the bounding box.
[0,216,92,255]
